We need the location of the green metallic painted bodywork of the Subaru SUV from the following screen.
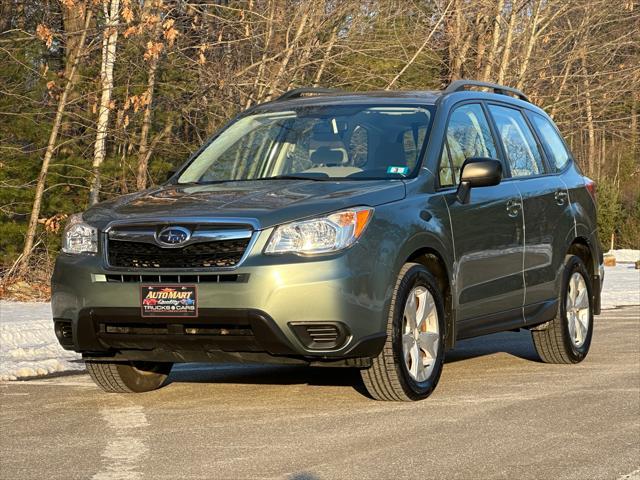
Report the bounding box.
[52,92,601,364]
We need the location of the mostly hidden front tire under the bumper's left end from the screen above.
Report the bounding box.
[85,360,173,393]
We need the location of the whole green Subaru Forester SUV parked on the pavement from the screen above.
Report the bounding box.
[52,80,603,400]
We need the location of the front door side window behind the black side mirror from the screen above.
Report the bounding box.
[438,103,497,187]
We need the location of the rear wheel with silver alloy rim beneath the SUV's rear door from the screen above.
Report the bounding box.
[531,255,593,364]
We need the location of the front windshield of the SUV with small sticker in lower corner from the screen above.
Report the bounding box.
[178,105,431,183]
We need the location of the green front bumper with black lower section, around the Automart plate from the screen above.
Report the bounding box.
[52,232,393,361]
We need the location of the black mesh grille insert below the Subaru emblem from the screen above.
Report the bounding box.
[107,238,249,268]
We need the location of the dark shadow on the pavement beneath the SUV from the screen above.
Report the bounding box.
[167,331,540,396]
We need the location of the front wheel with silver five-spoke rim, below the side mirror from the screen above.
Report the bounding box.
[360,263,444,401]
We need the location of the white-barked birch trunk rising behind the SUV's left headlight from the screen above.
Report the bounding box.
[89,0,120,205]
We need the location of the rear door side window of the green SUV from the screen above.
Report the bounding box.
[489,105,544,177]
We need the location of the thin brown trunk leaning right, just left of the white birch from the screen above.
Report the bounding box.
[11,8,92,276]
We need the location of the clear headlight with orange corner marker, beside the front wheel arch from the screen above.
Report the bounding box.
[264,207,373,255]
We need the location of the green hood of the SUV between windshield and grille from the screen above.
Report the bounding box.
[83,180,405,229]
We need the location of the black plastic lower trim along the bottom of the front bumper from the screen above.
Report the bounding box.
[62,307,386,363]
